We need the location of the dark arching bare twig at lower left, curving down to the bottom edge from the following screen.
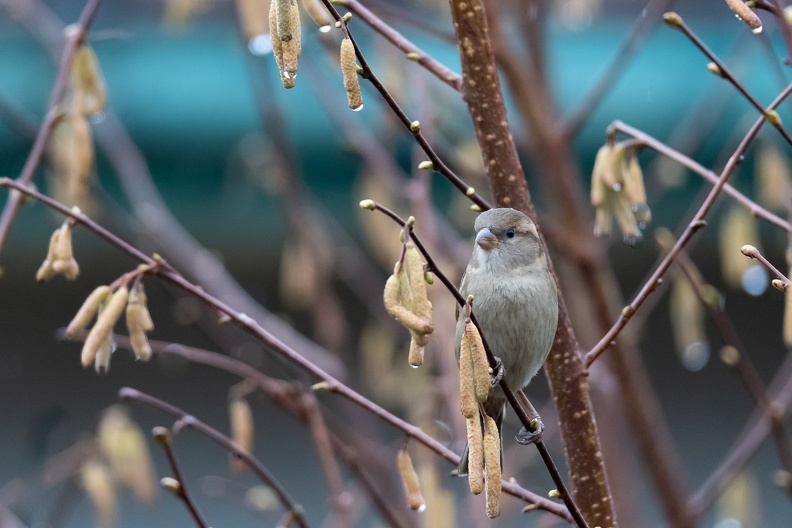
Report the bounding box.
[123,387,308,528]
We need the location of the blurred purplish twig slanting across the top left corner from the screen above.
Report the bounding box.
[0,0,101,251]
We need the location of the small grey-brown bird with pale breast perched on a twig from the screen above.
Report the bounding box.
[456,209,558,475]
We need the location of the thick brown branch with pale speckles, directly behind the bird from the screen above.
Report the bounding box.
[451,0,616,527]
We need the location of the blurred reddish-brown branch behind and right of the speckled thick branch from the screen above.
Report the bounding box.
[488,4,695,528]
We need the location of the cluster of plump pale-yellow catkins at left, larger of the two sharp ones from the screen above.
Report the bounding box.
[66,280,154,373]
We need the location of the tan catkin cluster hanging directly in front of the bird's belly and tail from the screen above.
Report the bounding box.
[459,321,501,519]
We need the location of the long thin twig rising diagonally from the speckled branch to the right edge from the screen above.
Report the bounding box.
[585,80,792,367]
